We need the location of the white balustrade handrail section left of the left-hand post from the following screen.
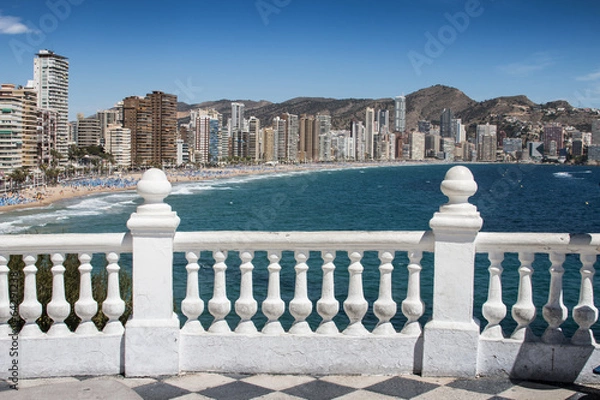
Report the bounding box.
[0,232,133,255]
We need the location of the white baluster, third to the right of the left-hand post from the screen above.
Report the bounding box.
[235,251,258,333]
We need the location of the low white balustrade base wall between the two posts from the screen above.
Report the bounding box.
[180,333,422,375]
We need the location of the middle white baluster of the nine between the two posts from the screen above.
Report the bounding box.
[290,250,312,334]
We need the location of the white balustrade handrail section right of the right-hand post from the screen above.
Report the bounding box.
[475,232,600,254]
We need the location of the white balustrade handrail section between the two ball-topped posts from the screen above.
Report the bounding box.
[174,231,434,252]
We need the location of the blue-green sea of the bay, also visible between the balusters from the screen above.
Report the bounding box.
[0,164,600,336]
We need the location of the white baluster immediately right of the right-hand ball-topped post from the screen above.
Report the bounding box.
[481,252,506,339]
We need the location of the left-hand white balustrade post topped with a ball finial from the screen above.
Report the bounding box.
[125,168,179,376]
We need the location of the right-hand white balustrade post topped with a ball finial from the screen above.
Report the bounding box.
[423,166,483,376]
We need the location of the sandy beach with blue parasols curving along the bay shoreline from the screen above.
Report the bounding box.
[0,162,412,212]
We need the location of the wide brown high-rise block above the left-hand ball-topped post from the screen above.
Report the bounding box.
[123,91,177,166]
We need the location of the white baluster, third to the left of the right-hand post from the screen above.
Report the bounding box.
[343,251,369,336]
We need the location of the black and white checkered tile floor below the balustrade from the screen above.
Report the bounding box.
[0,373,600,400]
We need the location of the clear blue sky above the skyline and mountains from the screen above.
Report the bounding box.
[0,0,600,118]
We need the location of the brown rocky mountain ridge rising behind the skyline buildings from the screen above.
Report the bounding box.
[177,85,600,137]
